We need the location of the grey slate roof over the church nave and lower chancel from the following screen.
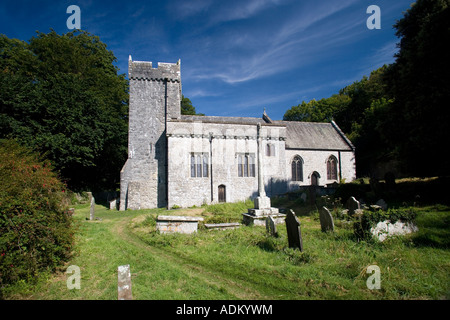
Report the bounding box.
[181,114,355,151]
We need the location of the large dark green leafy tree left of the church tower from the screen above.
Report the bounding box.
[0,30,128,190]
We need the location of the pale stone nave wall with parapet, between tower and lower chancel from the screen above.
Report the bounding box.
[167,122,285,207]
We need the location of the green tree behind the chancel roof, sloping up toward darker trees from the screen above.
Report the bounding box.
[284,65,393,176]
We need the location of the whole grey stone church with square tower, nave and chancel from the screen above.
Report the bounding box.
[120,56,356,210]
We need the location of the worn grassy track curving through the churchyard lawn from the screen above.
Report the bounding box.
[112,212,269,300]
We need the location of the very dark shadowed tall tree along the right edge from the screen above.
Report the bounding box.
[386,0,450,175]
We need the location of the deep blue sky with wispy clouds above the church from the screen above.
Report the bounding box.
[0,0,414,120]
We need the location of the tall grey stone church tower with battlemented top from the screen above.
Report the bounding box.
[120,56,181,210]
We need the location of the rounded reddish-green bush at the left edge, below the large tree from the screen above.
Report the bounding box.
[0,140,74,290]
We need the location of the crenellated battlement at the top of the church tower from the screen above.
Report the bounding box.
[128,56,181,83]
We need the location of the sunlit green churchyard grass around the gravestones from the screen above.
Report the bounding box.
[1,203,450,300]
